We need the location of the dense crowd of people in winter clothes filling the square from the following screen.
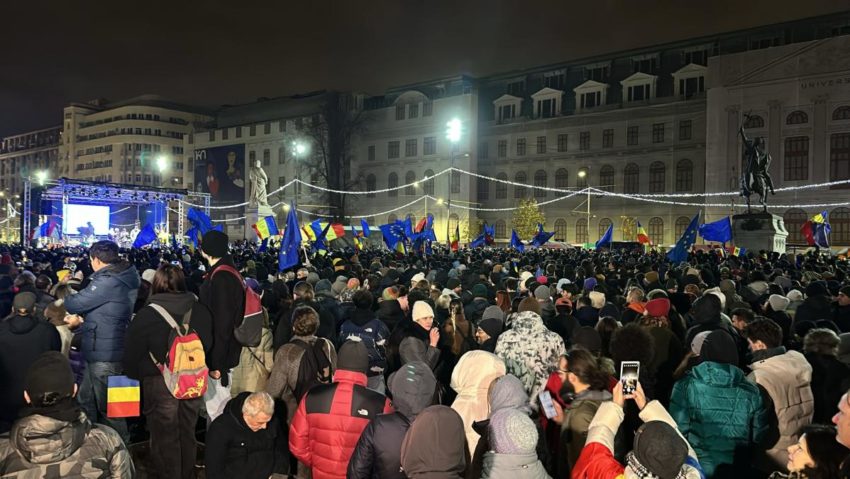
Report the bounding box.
[0,231,850,479]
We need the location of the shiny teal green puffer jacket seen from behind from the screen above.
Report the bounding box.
[670,361,768,478]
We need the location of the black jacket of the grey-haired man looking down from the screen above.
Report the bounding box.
[204,392,287,479]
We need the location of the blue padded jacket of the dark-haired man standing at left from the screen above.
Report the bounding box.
[65,262,141,362]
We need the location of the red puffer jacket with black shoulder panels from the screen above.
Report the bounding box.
[289,369,393,479]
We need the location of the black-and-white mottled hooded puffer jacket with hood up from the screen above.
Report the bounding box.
[496,311,566,409]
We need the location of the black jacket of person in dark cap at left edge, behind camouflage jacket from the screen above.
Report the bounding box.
[0,315,62,433]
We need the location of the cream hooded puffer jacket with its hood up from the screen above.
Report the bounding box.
[451,351,505,457]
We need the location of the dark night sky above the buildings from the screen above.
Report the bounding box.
[0,0,850,137]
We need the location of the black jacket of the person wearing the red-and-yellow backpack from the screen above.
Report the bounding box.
[124,293,213,379]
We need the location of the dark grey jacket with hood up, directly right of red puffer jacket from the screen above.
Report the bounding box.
[347,361,437,479]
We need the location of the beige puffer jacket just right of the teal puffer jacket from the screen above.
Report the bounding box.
[747,351,815,469]
